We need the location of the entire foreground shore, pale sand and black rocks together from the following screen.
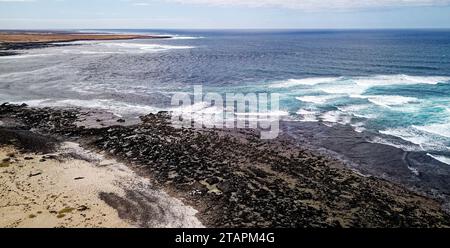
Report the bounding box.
[0,104,450,228]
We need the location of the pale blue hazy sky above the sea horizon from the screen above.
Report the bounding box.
[0,0,450,29]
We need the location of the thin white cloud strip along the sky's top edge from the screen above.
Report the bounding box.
[166,0,450,10]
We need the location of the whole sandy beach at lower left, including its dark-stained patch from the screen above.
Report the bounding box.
[0,127,202,228]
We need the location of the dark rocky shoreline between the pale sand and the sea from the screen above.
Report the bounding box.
[0,104,450,227]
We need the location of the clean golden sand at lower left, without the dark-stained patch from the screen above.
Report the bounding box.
[0,147,132,227]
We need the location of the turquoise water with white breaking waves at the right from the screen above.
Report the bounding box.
[260,74,450,163]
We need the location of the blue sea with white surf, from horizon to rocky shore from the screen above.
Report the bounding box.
[0,30,450,164]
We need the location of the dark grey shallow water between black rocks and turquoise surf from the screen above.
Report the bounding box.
[282,121,450,213]
